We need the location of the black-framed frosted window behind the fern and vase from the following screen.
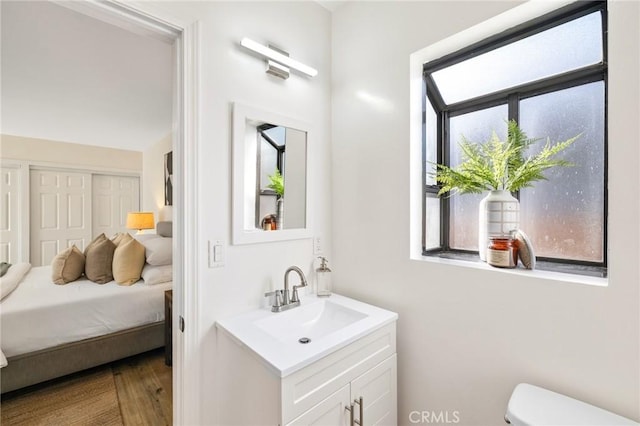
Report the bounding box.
[422,2,607,276]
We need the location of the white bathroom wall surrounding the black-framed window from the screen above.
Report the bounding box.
[332,1,640,425]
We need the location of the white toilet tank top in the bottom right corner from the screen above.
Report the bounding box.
[504,383,640,426]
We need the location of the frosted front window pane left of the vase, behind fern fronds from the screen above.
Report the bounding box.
[449,105,508,250]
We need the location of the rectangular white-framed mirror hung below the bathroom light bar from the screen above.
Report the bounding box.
[233,103,311,244]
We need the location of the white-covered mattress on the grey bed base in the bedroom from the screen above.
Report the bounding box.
[0,266,172,357]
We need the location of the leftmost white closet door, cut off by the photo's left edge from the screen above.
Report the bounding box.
[0,166,22,263]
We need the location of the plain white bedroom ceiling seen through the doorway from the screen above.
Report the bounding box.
[0,1,173,151]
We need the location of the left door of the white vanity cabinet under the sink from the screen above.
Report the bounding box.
[287,385,350,426]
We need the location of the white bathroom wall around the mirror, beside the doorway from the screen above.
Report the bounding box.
[140,2,331,425]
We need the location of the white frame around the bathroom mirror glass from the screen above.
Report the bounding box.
[232,102,315,244]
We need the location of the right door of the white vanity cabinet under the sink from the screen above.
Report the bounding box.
[351,354,398,426]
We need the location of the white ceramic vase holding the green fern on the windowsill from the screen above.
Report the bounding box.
[478,191,520,262]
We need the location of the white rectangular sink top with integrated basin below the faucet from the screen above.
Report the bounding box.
[216,294,398,377]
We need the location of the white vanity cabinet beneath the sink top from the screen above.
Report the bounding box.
[217,321,397,426]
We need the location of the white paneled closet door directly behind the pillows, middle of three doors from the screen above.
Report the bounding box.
[30,170,91,266]
